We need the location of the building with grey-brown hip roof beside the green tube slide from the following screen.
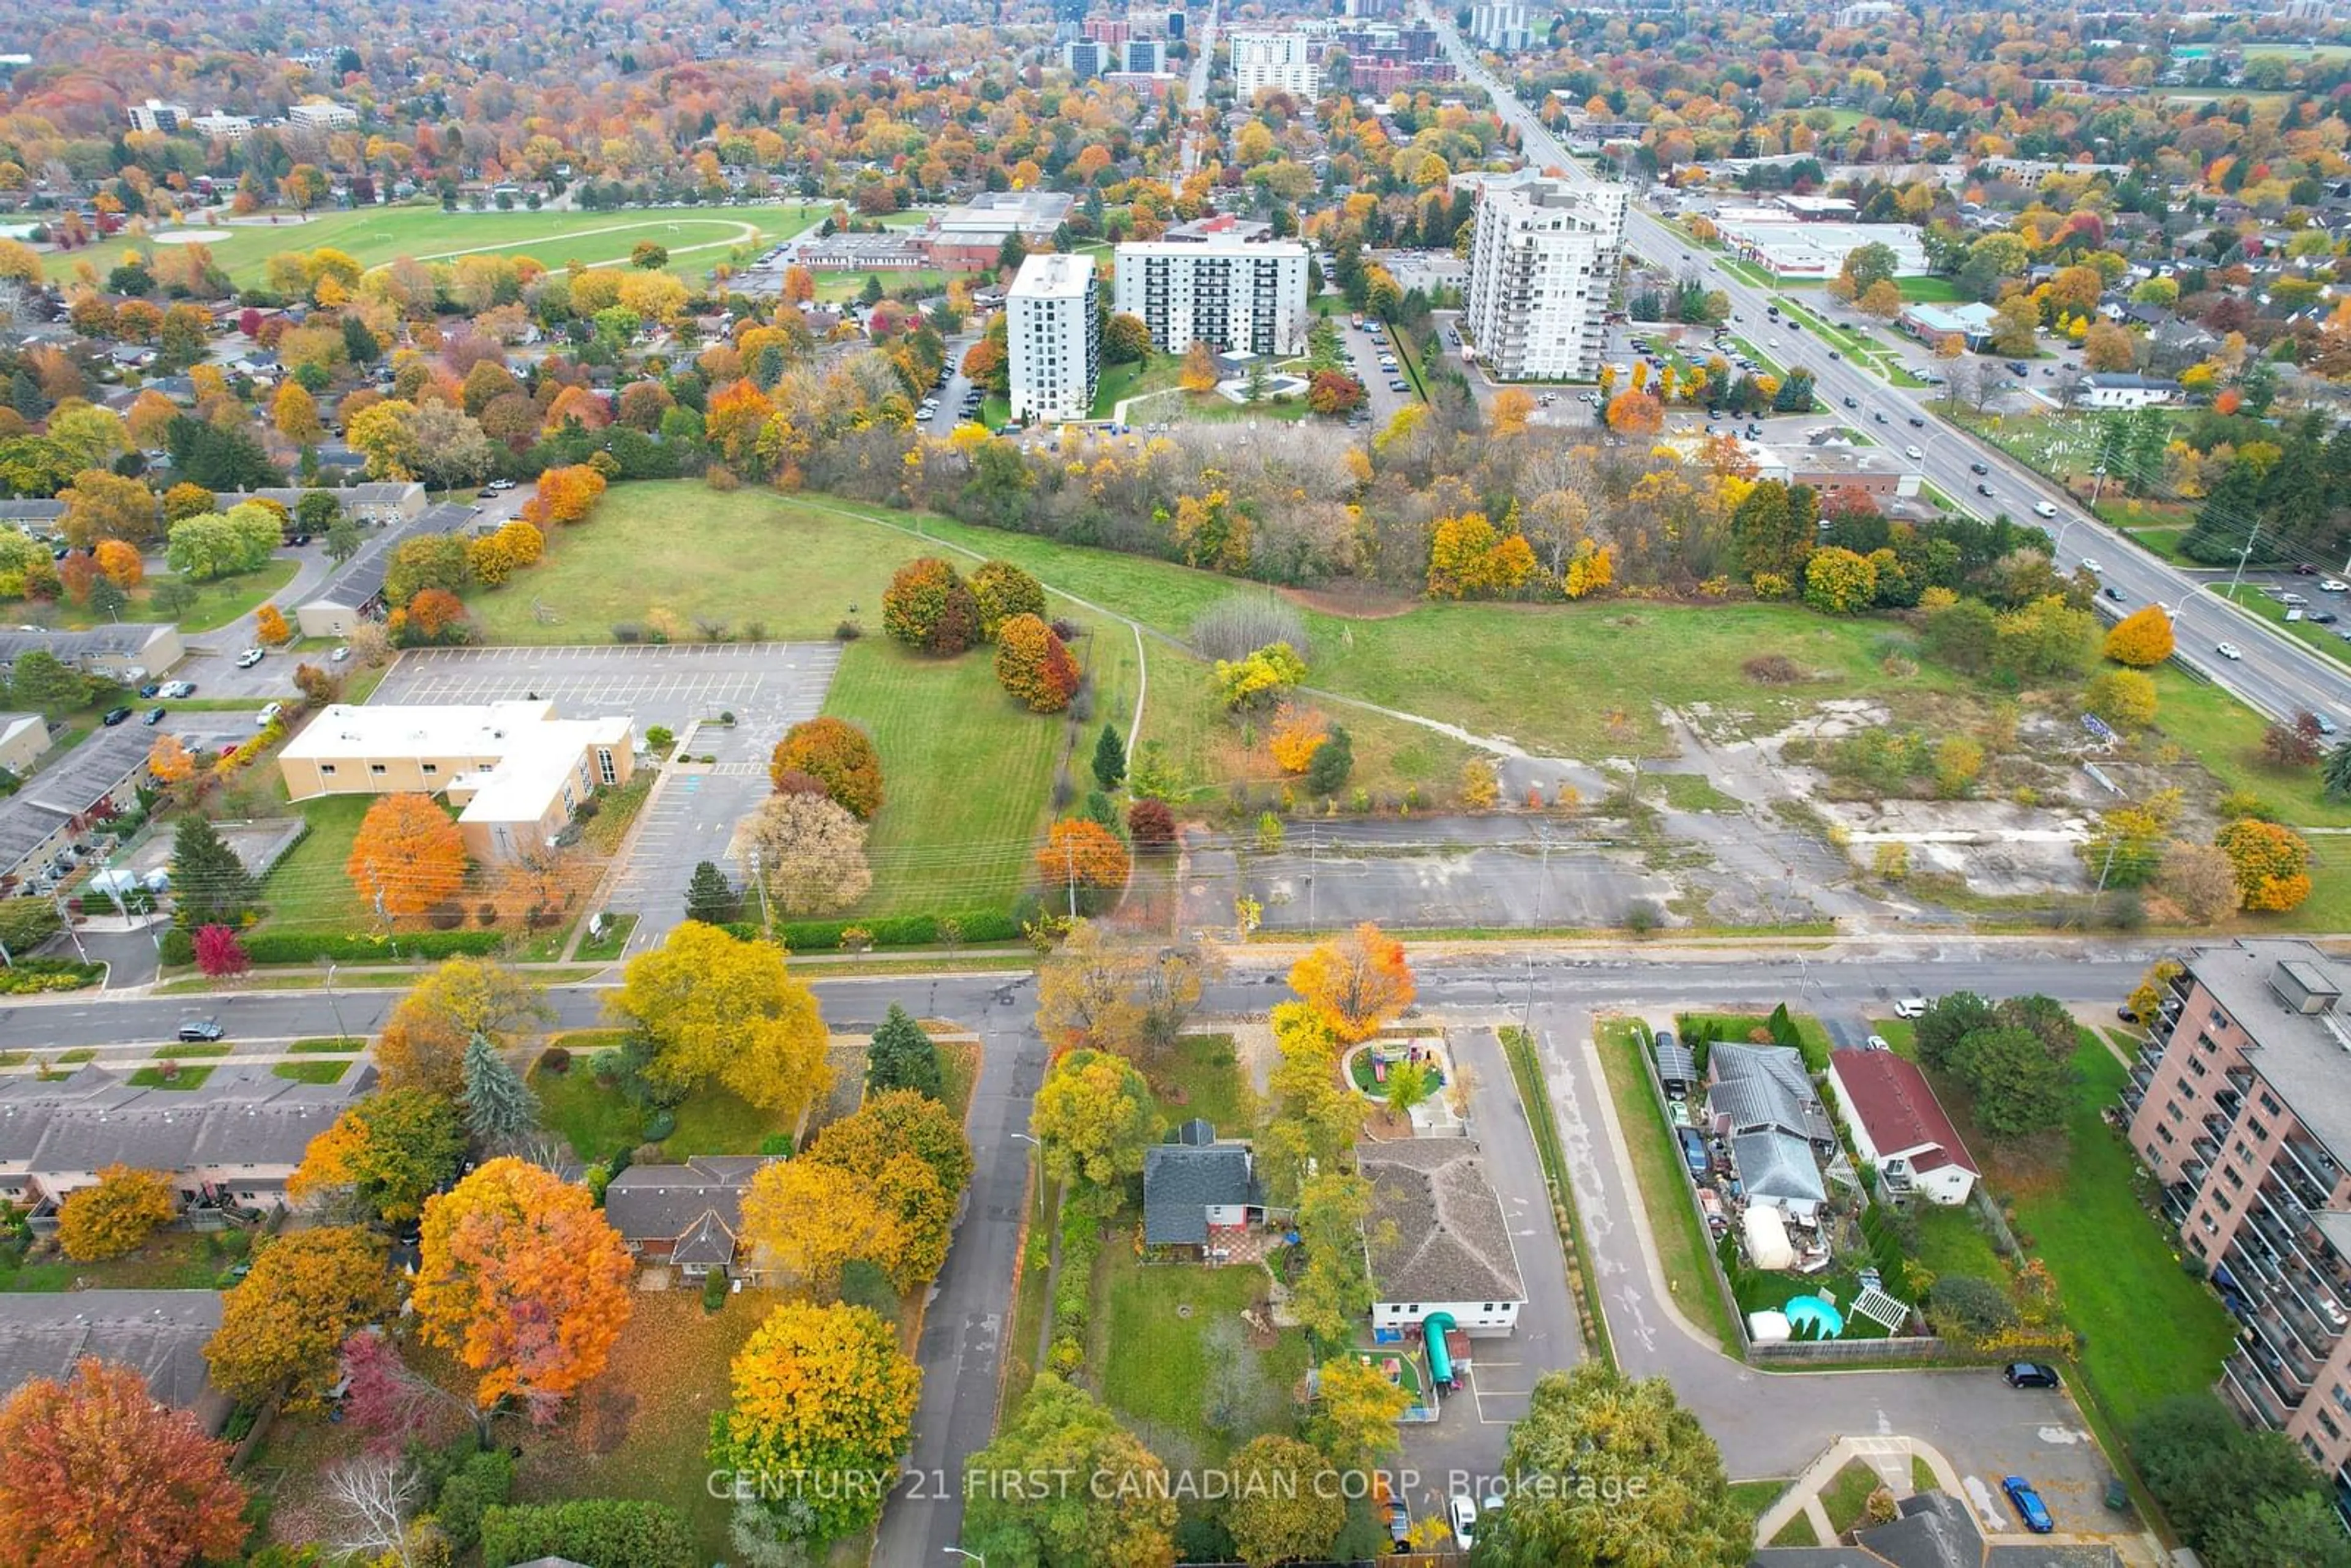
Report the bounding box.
[1354,1138,1526,1338]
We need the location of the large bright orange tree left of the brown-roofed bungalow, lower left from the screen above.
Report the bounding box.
[414,1159,635,1422]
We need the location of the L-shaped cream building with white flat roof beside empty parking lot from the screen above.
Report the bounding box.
[277,700,637,860]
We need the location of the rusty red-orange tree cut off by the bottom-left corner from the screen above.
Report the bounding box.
[0,1356,247,1568]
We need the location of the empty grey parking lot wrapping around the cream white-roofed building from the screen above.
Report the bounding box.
[369,642,839,952]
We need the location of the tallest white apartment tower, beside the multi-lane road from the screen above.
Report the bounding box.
[1462,176,1624,381]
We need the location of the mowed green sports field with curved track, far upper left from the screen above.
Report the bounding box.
[112,202,832,287]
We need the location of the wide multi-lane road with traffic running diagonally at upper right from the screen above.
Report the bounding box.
[1425,12,2351,724]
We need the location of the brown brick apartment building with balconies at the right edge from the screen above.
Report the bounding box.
[2123,940,2351,1509]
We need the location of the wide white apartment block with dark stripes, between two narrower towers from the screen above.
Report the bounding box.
[1112,240,1307,355]
